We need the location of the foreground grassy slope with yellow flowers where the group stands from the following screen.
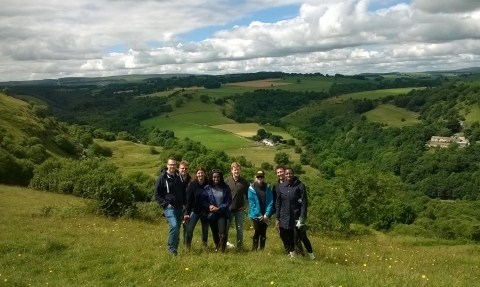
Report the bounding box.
[0,186,480,287]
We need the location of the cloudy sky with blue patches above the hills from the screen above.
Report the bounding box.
[0,0,480,81]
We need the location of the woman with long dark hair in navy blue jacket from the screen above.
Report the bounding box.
[202,169,232,252]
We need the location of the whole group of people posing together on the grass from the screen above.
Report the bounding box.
[155,157,315,259]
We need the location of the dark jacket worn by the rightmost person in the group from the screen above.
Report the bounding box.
[275,177,308,229]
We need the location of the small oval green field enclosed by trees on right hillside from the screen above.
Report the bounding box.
[364,105,420,127]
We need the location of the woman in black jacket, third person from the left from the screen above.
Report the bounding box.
[186,166,209,247]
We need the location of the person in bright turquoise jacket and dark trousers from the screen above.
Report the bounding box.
[248,170,273,250]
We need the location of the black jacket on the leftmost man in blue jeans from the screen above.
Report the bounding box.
[155,168,187,209]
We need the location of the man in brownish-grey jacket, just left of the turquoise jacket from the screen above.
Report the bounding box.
[225,162,250,248]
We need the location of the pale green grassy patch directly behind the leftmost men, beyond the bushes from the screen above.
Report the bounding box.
[95,139,164,177]
